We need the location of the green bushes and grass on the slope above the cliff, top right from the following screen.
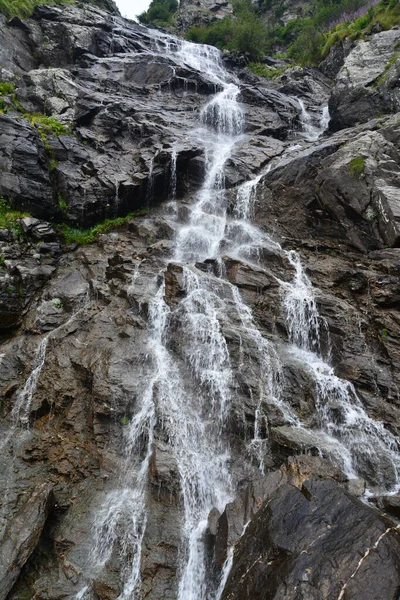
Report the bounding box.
[186,0,400,66]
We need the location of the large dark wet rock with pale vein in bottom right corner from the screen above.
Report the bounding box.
[222,480,400,600]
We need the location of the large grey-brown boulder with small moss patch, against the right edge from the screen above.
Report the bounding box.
[255,119,400,251]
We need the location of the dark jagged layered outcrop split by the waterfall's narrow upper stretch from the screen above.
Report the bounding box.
[0,7,299,226]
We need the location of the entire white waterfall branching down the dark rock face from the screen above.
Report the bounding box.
[76,25,400,600]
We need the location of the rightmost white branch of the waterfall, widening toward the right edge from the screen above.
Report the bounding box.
[282,251,400,492]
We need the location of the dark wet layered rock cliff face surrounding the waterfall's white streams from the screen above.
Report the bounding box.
[0,3,400,600]
